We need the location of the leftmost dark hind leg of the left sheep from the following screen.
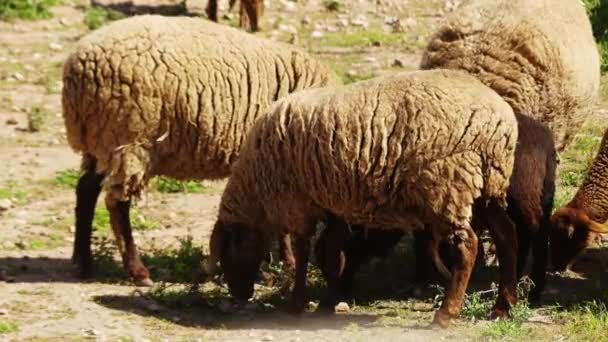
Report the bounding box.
[72,158,104,278]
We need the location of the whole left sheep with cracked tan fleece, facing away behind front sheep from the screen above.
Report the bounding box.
[62,15,338,285]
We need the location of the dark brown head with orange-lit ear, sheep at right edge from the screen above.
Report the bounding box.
[550,207,608,271]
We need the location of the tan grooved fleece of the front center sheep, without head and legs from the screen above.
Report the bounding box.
[234,71,517,225]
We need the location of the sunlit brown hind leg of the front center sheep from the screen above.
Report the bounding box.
[433,227,478,327]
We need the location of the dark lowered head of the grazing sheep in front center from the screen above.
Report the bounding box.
[210,221,267,301]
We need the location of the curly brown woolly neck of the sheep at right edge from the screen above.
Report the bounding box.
[569,130,608,223]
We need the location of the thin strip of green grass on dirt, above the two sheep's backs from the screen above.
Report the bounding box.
[320,28,402,48]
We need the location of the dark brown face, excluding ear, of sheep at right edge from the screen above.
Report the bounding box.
[549,215,594,271]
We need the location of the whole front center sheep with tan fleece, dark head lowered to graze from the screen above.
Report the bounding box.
[209,70,517,326]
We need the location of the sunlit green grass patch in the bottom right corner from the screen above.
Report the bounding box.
[558,300,608,342]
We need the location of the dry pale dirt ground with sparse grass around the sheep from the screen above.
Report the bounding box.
[0,0,608,341]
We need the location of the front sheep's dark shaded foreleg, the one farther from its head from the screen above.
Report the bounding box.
[320,215,349,311]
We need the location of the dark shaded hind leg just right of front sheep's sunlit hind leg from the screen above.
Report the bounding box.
[476,202,517,317]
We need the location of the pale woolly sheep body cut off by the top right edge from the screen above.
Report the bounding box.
[420,0,600,151]
